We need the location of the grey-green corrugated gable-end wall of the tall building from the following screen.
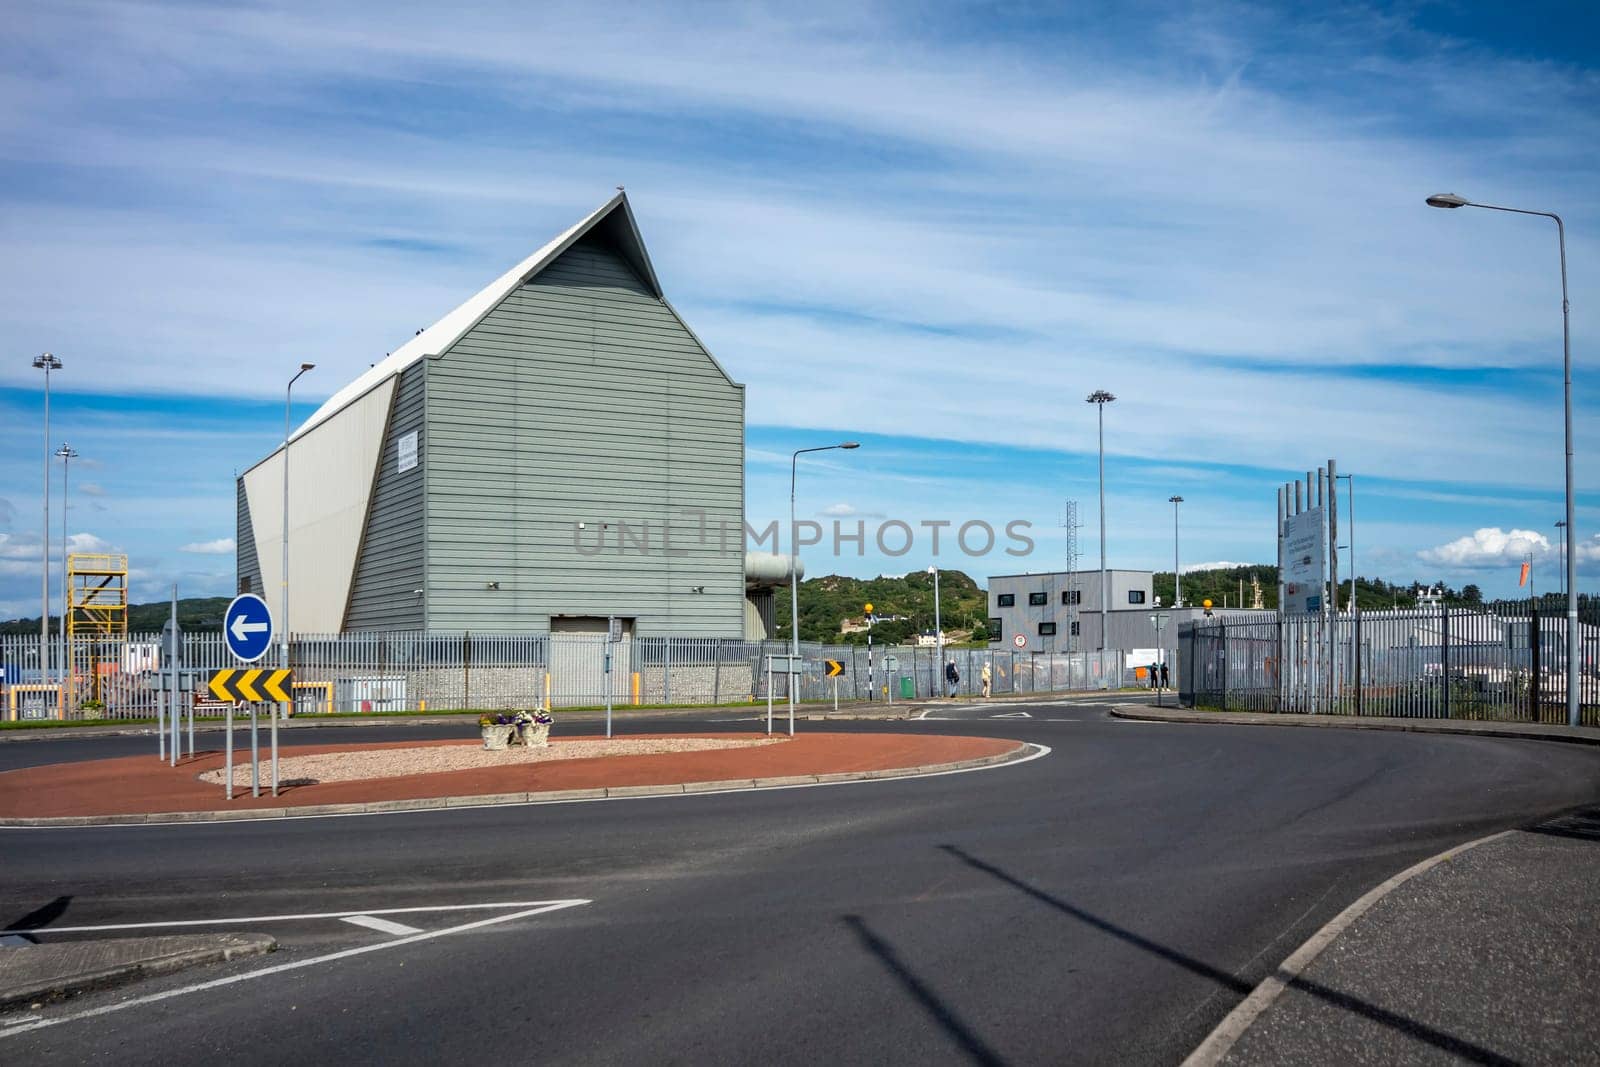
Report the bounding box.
[427,235,744,637]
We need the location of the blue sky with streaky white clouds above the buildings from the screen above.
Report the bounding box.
[0,0,1600,617]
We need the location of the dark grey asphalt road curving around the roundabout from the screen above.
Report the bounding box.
[0,702,1600,1064]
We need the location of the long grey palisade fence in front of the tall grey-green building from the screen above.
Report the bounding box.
[0,632,1142,718]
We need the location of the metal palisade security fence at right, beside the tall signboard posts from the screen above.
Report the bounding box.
[1178,601,1600,726]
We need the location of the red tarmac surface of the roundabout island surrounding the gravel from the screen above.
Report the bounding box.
[0,733,1019,819]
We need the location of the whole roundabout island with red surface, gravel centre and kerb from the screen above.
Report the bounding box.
[0,733,1040,825]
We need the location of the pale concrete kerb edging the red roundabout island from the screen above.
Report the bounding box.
[0,742,1032,829]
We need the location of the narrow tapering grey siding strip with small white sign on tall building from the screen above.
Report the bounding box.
[344,360,427,630]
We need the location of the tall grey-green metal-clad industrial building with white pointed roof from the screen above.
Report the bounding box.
[237,192,754,637]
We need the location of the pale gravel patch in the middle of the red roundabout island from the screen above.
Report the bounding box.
[200,737,787,787]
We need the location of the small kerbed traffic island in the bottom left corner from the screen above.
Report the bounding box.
[0,934,278,1008]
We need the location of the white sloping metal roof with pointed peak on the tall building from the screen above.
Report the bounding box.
[284,190,661,454]
